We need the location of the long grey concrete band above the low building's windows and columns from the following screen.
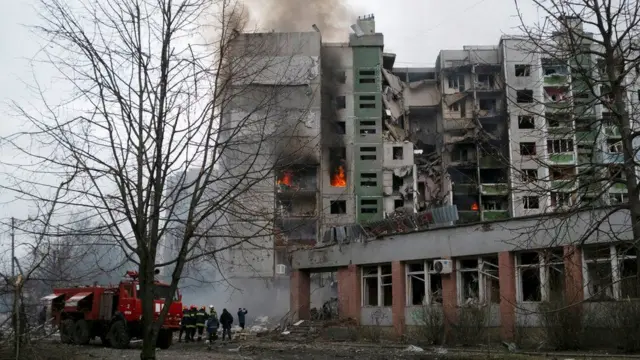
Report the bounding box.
[292,209,631,269]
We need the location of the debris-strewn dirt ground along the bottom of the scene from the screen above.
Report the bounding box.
[0,340,632,360]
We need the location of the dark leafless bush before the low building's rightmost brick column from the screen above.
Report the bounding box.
[538,301,584,350]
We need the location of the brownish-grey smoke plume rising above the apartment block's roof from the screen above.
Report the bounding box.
[245,0,357,42]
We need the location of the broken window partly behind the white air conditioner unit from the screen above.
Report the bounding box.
[406,260,442,306]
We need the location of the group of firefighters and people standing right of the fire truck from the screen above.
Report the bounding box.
[178,305,248,343]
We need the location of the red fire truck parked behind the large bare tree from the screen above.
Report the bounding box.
[43,271,182,349]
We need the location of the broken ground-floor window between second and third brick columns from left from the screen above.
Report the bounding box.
[362,265,393,306]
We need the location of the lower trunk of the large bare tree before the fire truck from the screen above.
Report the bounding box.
[139,256,158,360]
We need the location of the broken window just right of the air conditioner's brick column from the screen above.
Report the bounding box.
[457,256,500,306]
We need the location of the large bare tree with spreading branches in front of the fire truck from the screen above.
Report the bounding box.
[0,0,319,359]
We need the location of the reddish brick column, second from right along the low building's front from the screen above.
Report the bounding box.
[498,251,516,341]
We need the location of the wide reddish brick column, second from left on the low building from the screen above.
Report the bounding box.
[338,264,362,324]
